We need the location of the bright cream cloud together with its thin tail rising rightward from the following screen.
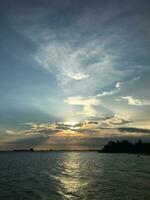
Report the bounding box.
[64,77,142,120]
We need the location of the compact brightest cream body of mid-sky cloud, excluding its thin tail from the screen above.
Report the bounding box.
[64,96,100,117]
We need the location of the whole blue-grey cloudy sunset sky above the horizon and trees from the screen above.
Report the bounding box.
[0,0,150,150]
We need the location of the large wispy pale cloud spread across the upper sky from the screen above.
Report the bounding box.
[33,33,135,90]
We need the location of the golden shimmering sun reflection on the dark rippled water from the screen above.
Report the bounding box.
[57,152,88,199]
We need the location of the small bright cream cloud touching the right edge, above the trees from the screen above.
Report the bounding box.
[120,96,150,106]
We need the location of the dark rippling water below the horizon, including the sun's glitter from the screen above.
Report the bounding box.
[0,152,150,200]
